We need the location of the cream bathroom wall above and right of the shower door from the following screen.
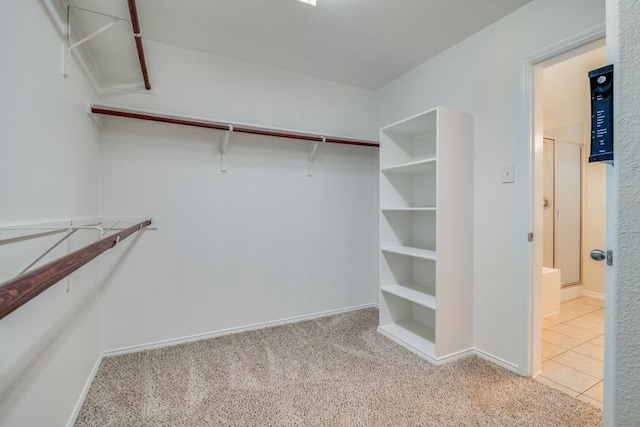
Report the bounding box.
[544,47,606,295]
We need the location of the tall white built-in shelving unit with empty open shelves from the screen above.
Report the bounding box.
[378,107,473,363]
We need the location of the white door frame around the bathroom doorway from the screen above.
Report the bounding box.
[519,24,605,376]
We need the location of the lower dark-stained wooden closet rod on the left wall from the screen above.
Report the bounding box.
[0,220,151,319]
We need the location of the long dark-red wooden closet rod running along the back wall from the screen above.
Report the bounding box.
[91,106,380,147]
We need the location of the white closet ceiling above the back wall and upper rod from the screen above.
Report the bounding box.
[71,0,531,89]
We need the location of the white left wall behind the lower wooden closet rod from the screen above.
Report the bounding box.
[0,1,101,426]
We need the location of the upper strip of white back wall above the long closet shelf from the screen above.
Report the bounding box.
[102,41,378,140]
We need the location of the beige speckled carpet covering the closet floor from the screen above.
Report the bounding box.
[76,309,602,427]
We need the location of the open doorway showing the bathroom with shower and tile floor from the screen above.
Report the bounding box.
[528,29,606,408]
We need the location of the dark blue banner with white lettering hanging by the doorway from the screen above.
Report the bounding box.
[589,64,613,164]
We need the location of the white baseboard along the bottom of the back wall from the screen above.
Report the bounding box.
[103,303,377,357]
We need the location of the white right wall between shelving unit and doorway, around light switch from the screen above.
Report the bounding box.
[377,0,605,372]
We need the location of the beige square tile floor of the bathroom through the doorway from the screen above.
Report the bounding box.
[536,297,604,409]
